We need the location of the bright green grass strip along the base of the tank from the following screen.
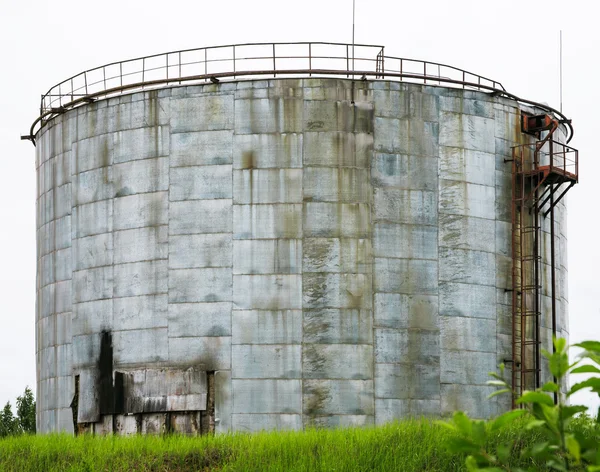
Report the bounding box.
[0,420,599,472]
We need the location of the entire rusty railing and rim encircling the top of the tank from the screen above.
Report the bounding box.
[21,42,574,145]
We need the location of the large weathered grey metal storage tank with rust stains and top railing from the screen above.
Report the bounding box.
[25,43,576,434]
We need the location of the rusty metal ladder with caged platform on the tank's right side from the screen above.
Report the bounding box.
[512,113,579,408]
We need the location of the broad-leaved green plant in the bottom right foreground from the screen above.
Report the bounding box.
[440,339,600,472]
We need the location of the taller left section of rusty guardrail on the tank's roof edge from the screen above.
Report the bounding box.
[40,42,384,114]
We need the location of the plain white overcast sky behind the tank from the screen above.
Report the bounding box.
[0,0,600,407]
